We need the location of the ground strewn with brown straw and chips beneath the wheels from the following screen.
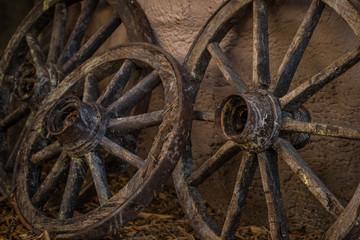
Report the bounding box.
[0,178,321,240]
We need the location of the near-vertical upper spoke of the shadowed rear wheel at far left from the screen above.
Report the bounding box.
[47,2,67,64]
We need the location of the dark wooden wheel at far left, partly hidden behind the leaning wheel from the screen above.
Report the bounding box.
[0,0,152,196]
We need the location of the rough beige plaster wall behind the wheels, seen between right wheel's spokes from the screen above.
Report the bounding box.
[103,0,360,232]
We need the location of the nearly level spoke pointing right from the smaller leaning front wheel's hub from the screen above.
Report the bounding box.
[108,111,164,133]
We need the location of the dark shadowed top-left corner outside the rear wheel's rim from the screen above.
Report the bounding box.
[0,0,36,54]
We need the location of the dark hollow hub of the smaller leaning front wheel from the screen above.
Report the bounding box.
[47,96,107,157]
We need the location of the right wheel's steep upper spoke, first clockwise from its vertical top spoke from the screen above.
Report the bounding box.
[271,0,325,97]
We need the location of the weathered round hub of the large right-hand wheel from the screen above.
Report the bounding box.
[215,91,282,152]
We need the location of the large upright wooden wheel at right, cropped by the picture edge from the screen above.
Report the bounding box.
[173,0,360,239]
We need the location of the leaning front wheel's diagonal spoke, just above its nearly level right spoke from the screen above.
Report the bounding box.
[106,70,161,116]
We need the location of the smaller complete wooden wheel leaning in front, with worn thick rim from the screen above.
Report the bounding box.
[15,43,191,239]
